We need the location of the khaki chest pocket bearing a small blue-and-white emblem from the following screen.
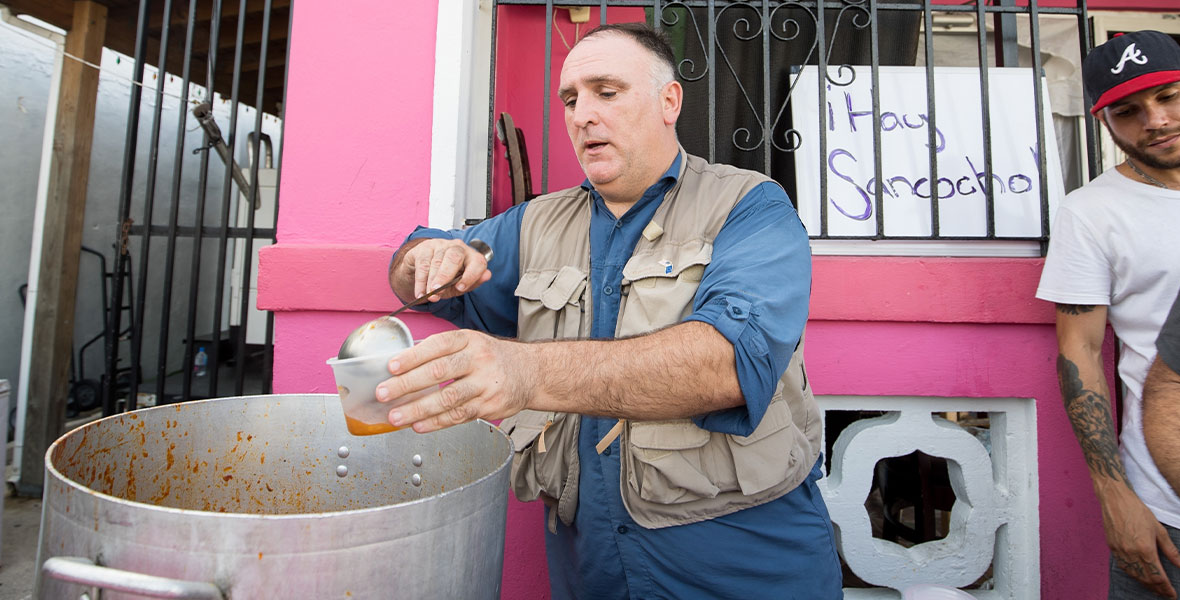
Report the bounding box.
[616,243,713,335]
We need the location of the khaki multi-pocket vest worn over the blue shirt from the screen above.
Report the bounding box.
[500,151,820,533]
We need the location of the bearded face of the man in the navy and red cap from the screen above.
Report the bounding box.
[1100,83,1180,169]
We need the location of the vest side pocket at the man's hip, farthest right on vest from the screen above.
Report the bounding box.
[726,390,799,496]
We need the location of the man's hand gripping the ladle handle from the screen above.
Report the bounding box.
[389,239,492,302]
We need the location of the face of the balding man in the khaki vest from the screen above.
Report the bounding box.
[558,33,680,201]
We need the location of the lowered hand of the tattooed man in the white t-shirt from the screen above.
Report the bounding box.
[1101,484,1180,599]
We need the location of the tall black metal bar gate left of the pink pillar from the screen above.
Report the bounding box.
[103,0,293,415]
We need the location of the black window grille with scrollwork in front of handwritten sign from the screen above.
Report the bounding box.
[487,0,1097,243]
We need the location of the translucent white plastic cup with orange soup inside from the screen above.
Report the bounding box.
[328,354,434,436]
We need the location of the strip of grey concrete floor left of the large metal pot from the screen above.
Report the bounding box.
[0,491,41,600]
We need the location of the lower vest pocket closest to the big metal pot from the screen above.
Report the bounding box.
[500,410,578,524]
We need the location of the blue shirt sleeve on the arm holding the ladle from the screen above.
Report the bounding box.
[406,204,526,338]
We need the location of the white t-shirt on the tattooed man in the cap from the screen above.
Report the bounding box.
[1036,169,1180,528]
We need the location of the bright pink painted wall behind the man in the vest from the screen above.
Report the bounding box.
[258,0,1107,599]
